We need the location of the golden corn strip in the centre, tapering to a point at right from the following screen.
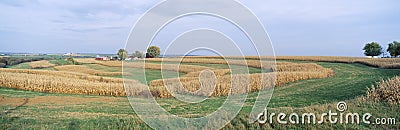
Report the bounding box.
[150,63,334,98]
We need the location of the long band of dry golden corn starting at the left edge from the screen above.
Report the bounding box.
[0,69,145,96]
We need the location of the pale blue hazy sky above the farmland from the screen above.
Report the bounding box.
[0,0,400,56]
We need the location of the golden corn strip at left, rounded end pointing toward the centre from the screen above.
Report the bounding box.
[0,68,148,96]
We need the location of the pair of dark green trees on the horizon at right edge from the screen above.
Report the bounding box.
[363,41,400,57]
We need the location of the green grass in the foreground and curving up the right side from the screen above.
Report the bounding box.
[0,61,400,129]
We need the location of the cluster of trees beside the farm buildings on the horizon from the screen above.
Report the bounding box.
[117,46,161,60]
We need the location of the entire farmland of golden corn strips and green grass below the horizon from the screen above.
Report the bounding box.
[0,57,400,129]
